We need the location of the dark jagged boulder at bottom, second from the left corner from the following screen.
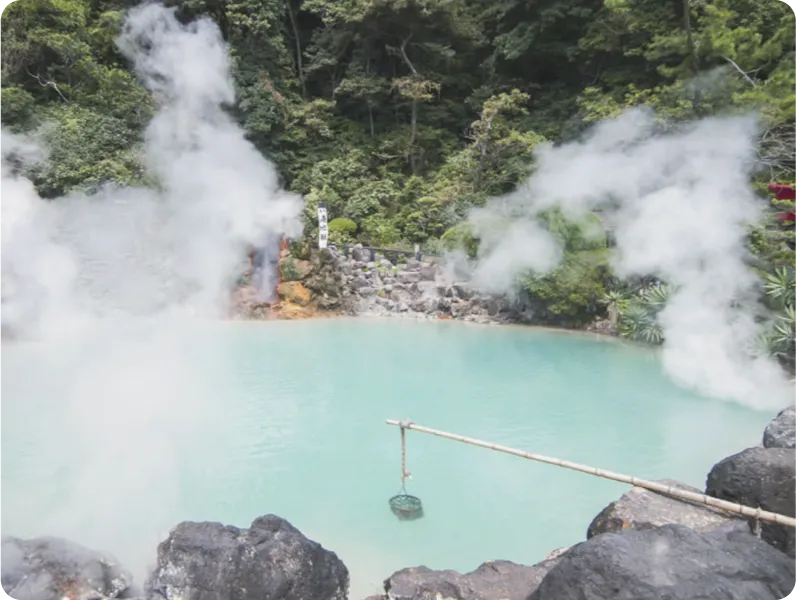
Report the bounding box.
[147,515,348,600]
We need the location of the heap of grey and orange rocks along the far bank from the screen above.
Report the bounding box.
[233,246,614,335]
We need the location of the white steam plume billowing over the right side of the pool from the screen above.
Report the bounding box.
[472,109,793,408]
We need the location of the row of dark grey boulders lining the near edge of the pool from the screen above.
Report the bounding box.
[6,406,796,600]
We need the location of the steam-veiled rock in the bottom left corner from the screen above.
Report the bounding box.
[0,537,132,600]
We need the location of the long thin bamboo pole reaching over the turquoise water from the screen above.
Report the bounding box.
[387,419,796,528]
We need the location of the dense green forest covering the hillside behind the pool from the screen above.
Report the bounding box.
[0,0,796,352]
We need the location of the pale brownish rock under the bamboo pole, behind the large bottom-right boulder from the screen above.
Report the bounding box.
[586,479,745,539]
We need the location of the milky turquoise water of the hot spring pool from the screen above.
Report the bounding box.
[0,320,772,599]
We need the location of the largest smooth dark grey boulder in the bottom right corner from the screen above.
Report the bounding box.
[528,525,796,600]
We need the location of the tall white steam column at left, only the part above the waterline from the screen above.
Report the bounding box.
[0,5,301,333]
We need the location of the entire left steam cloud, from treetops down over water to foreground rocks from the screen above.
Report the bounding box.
[0,4,302,574]
